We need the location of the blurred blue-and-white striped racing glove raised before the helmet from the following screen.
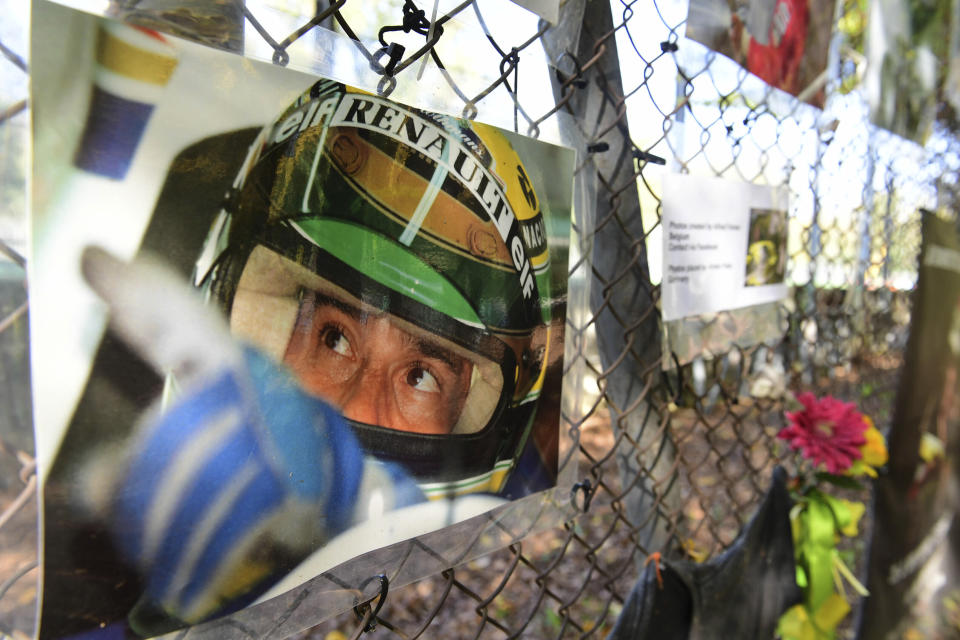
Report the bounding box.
[83,249,424,633]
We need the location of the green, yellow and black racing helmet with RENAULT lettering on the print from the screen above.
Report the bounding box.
[195,80,551,497]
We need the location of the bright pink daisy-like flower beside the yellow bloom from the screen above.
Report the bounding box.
[777,392,869,474]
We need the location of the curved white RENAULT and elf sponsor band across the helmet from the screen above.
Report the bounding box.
[268,93,536,301]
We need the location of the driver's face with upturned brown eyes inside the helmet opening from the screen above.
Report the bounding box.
[283,293,472,434]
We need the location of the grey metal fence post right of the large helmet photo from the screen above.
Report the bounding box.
[544,0,673,552]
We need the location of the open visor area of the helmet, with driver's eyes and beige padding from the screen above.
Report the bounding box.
[230,245,504,434]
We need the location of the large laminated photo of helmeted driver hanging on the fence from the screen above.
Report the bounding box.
[30,2,573,638]
